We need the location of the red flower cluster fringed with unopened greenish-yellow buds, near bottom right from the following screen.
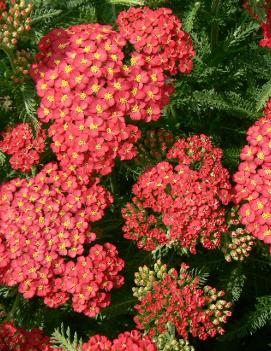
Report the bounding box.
[133,261,231,340]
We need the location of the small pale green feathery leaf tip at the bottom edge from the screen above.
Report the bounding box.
[51,323,82,351]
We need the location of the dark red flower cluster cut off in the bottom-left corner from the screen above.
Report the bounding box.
[0,323,56,351]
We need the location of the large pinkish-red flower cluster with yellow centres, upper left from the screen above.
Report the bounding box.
[30,20,176,175]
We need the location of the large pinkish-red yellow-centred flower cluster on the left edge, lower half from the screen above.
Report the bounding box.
[0,163,124,316]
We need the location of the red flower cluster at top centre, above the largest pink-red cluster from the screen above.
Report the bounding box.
[117,7,195,74]
